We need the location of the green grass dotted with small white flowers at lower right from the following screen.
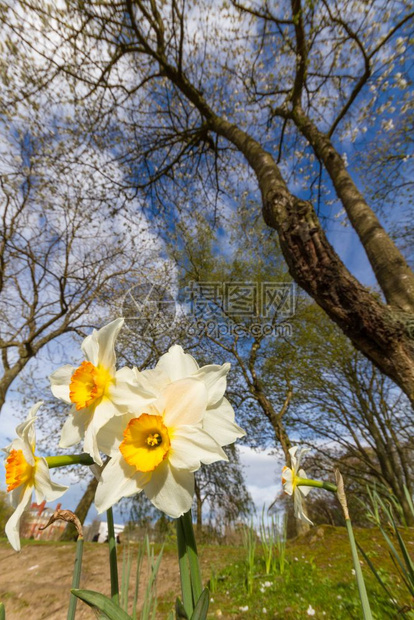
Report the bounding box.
[159,526,414,620]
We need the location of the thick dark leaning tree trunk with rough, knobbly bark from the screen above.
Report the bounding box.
[211,117,414,405]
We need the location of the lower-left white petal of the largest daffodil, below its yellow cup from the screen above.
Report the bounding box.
[95,454,151,513]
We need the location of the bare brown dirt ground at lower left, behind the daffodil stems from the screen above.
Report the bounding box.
[0,542,239,620]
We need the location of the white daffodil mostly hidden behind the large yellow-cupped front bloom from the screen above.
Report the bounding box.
[109,345,246,451]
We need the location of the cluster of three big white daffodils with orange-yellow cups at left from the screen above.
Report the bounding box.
[1,319,245,549]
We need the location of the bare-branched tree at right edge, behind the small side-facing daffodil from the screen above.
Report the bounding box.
[272,306,414,523]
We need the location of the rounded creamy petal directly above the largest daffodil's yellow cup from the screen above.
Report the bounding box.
[162,379,207,427]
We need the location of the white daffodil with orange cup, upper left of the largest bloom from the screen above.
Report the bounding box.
[50,319,155,465]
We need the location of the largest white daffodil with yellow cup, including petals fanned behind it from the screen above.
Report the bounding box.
[95,354,244,518]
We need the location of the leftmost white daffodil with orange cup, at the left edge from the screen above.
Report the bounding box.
[3,402,68,551]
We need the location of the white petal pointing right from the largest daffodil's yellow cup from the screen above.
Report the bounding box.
[168,426,228,471]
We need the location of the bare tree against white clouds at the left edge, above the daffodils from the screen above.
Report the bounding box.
[0,115,157,409]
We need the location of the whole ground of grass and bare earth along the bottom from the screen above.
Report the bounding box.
[0,526,414,620]
